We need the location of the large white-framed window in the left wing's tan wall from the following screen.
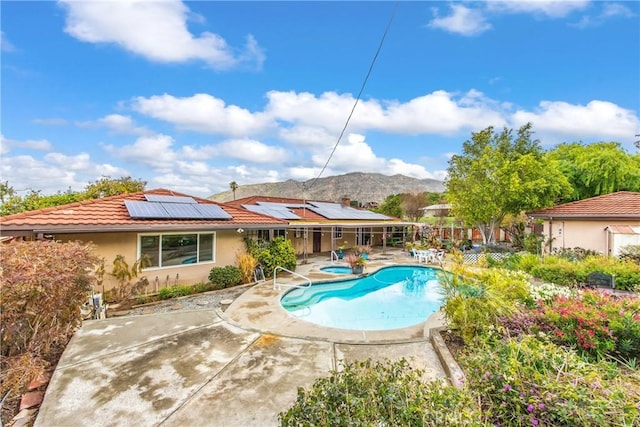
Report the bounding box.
[140,233,216,267]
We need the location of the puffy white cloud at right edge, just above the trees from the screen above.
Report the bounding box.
[512,100,640,143]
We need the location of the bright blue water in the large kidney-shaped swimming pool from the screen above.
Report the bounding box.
[281,266,442,331]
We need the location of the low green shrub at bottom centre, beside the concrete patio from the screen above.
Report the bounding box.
[278,359,483,427]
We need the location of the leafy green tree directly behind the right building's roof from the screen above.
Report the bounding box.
[549,142,640,201]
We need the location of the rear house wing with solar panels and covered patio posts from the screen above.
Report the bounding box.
[225,196,413,255]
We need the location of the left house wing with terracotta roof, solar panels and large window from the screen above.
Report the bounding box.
[0,189,288,289]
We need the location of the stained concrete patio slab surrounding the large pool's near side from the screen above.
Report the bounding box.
[35,252,445,427]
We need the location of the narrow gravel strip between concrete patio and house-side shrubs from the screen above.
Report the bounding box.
[115,286,250,317]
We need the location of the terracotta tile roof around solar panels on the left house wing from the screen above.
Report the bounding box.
[0,188,287,234]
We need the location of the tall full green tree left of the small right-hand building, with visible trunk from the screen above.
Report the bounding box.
[445,123,571,244]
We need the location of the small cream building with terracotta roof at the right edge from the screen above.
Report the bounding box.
[527,191,640,256]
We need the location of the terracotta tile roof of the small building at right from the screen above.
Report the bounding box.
[527,191,640,219]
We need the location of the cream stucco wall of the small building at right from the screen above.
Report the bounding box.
[544,219,640,255]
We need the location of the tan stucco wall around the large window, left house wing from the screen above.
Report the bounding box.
[56,230,245,292]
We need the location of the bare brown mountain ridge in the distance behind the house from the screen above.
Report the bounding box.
[208,172,444,205]
